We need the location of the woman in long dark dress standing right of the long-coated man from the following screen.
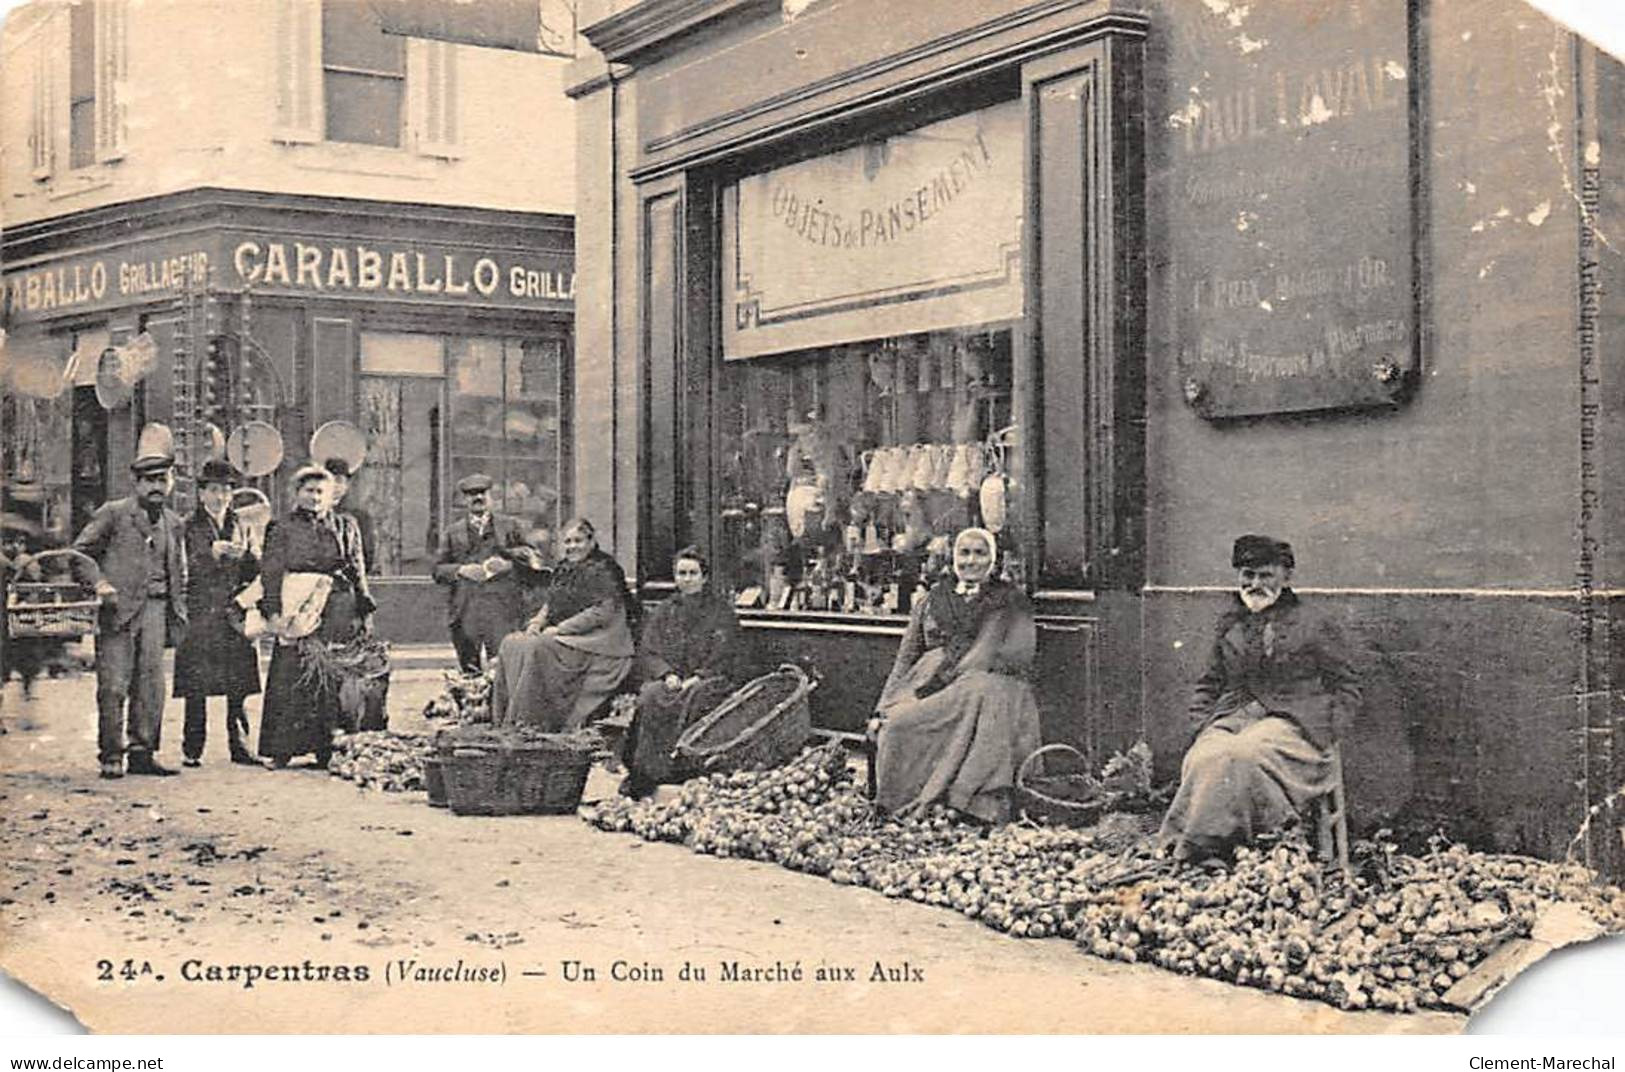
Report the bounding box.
[260,466,374,767]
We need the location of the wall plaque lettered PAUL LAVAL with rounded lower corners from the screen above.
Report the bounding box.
[1165,0,1415,417]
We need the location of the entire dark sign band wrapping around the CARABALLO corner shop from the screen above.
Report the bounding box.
[5,231,575,323]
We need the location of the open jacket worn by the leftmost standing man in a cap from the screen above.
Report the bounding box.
[73,495,187,640]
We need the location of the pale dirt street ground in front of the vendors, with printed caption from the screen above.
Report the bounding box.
[0,659,1466,1033]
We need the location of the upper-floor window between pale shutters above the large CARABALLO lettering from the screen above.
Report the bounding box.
[322,0,406,146]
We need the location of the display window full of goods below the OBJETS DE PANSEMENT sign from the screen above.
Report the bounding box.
[717,323,1025,612]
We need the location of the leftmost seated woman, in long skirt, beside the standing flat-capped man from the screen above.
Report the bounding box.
[491,518,632,733]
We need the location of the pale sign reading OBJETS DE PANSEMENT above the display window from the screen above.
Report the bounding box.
[723,101,1022,357]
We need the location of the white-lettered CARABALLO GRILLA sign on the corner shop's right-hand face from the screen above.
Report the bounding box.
[228,236,575,307]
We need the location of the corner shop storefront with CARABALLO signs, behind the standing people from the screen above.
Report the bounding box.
[0,192,574,642]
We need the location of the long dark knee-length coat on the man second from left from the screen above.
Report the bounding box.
[174,507,260,697]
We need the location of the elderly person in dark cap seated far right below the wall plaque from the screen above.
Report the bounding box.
[1160,536,1360,861]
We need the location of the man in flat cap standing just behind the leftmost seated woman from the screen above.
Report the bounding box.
[434,473,527,674]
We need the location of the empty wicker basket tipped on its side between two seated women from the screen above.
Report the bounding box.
[671,663,817,772]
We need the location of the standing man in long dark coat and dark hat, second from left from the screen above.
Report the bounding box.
[174,461,260,767]
